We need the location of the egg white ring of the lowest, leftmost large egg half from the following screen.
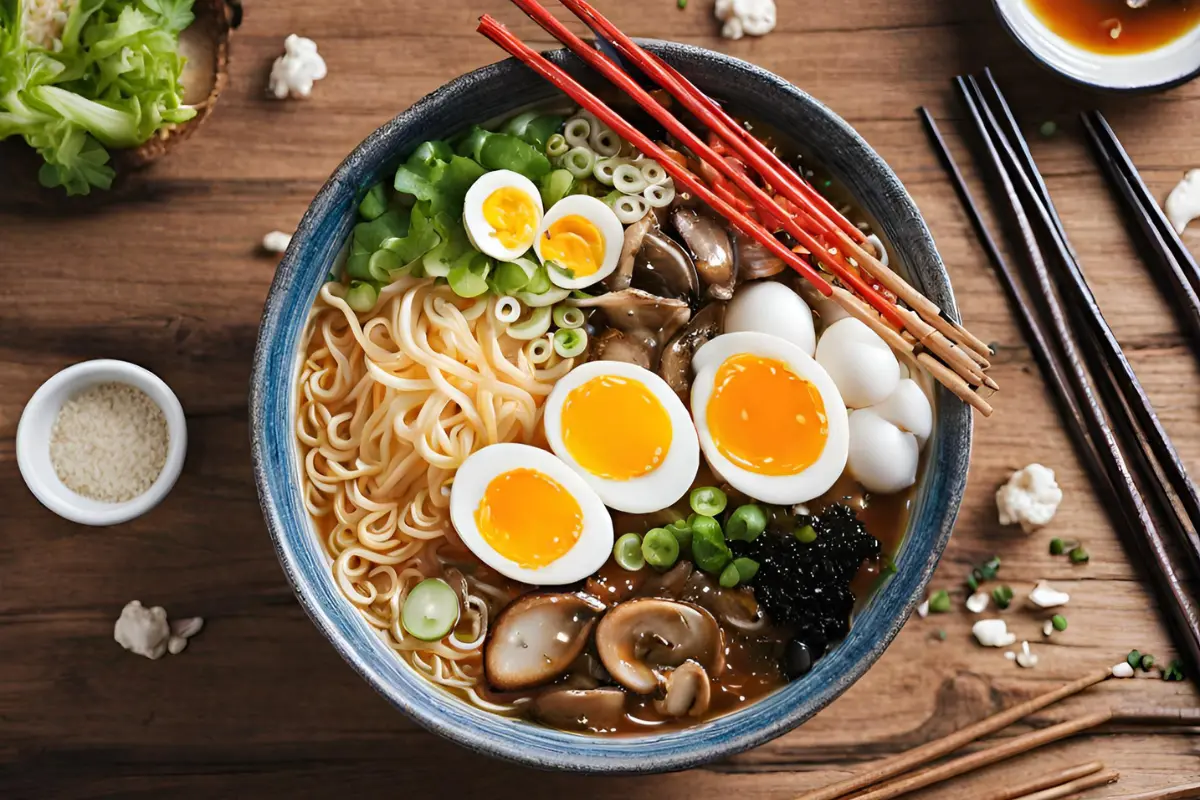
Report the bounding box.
[450,444,613,587]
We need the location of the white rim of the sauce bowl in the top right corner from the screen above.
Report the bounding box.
[992,0,1200,91]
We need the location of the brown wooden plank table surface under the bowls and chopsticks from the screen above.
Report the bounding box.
[0,0,1200,800]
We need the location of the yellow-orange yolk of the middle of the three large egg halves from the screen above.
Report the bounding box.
[563,375,672,481]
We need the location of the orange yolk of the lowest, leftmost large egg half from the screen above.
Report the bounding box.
[475,468,583,569]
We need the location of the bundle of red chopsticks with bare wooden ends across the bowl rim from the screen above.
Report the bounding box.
[479,0,998,415]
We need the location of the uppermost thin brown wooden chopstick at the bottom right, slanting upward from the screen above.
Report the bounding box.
[796,669,1112,800]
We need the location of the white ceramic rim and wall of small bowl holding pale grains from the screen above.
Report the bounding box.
[17,359,187,525]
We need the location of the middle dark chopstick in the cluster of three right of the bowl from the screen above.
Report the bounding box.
[955,78,1200,674]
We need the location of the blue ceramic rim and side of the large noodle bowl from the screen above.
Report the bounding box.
[250,42,971,772]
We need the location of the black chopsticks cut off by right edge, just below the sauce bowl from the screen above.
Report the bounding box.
[1080,112,1200,355]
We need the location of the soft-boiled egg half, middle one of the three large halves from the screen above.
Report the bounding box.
[542,361,700,513]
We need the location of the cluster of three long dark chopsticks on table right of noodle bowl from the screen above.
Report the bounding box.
[923,73,1200,675]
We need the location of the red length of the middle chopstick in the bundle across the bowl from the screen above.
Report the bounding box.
[496,0,905,329]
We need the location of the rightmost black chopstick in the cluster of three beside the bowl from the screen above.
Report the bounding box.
[970,74,1200,579]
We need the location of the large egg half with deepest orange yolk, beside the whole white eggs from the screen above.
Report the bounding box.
[691,331,850,505]
